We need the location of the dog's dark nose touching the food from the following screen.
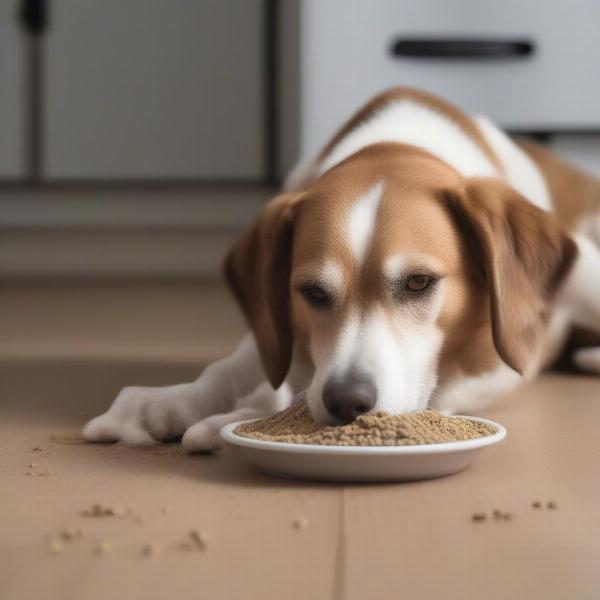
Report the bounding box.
[323,375,377,423]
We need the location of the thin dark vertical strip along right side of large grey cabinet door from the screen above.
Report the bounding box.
[263,0,279,184]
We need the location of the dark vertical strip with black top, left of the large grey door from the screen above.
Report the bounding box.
[19,0,48,181]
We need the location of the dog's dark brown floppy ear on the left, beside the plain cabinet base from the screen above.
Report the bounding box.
[224,194,299,388]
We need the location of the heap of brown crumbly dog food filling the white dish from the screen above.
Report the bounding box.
[235,403,496,446]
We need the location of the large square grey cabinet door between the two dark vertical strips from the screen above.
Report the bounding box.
[43,0,264,179]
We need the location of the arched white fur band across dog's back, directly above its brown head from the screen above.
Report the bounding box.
[318,100,498,177]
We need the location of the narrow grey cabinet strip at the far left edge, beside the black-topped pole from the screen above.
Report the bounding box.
[0,0,26,179]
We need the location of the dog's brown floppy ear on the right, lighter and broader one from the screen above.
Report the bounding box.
[447,178,577,374]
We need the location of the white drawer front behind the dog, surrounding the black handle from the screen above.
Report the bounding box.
[301,0,600,159]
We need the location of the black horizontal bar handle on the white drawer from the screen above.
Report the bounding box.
[391,37,535,60]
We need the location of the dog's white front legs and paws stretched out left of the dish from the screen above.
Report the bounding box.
[83,334,291,450]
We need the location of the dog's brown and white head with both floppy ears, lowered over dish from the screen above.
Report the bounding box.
[225,144,576,423]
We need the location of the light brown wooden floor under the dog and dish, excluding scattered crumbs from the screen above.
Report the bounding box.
[0,285,600,600]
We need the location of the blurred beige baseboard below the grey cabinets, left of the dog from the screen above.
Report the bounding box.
[0,186,273,278]
